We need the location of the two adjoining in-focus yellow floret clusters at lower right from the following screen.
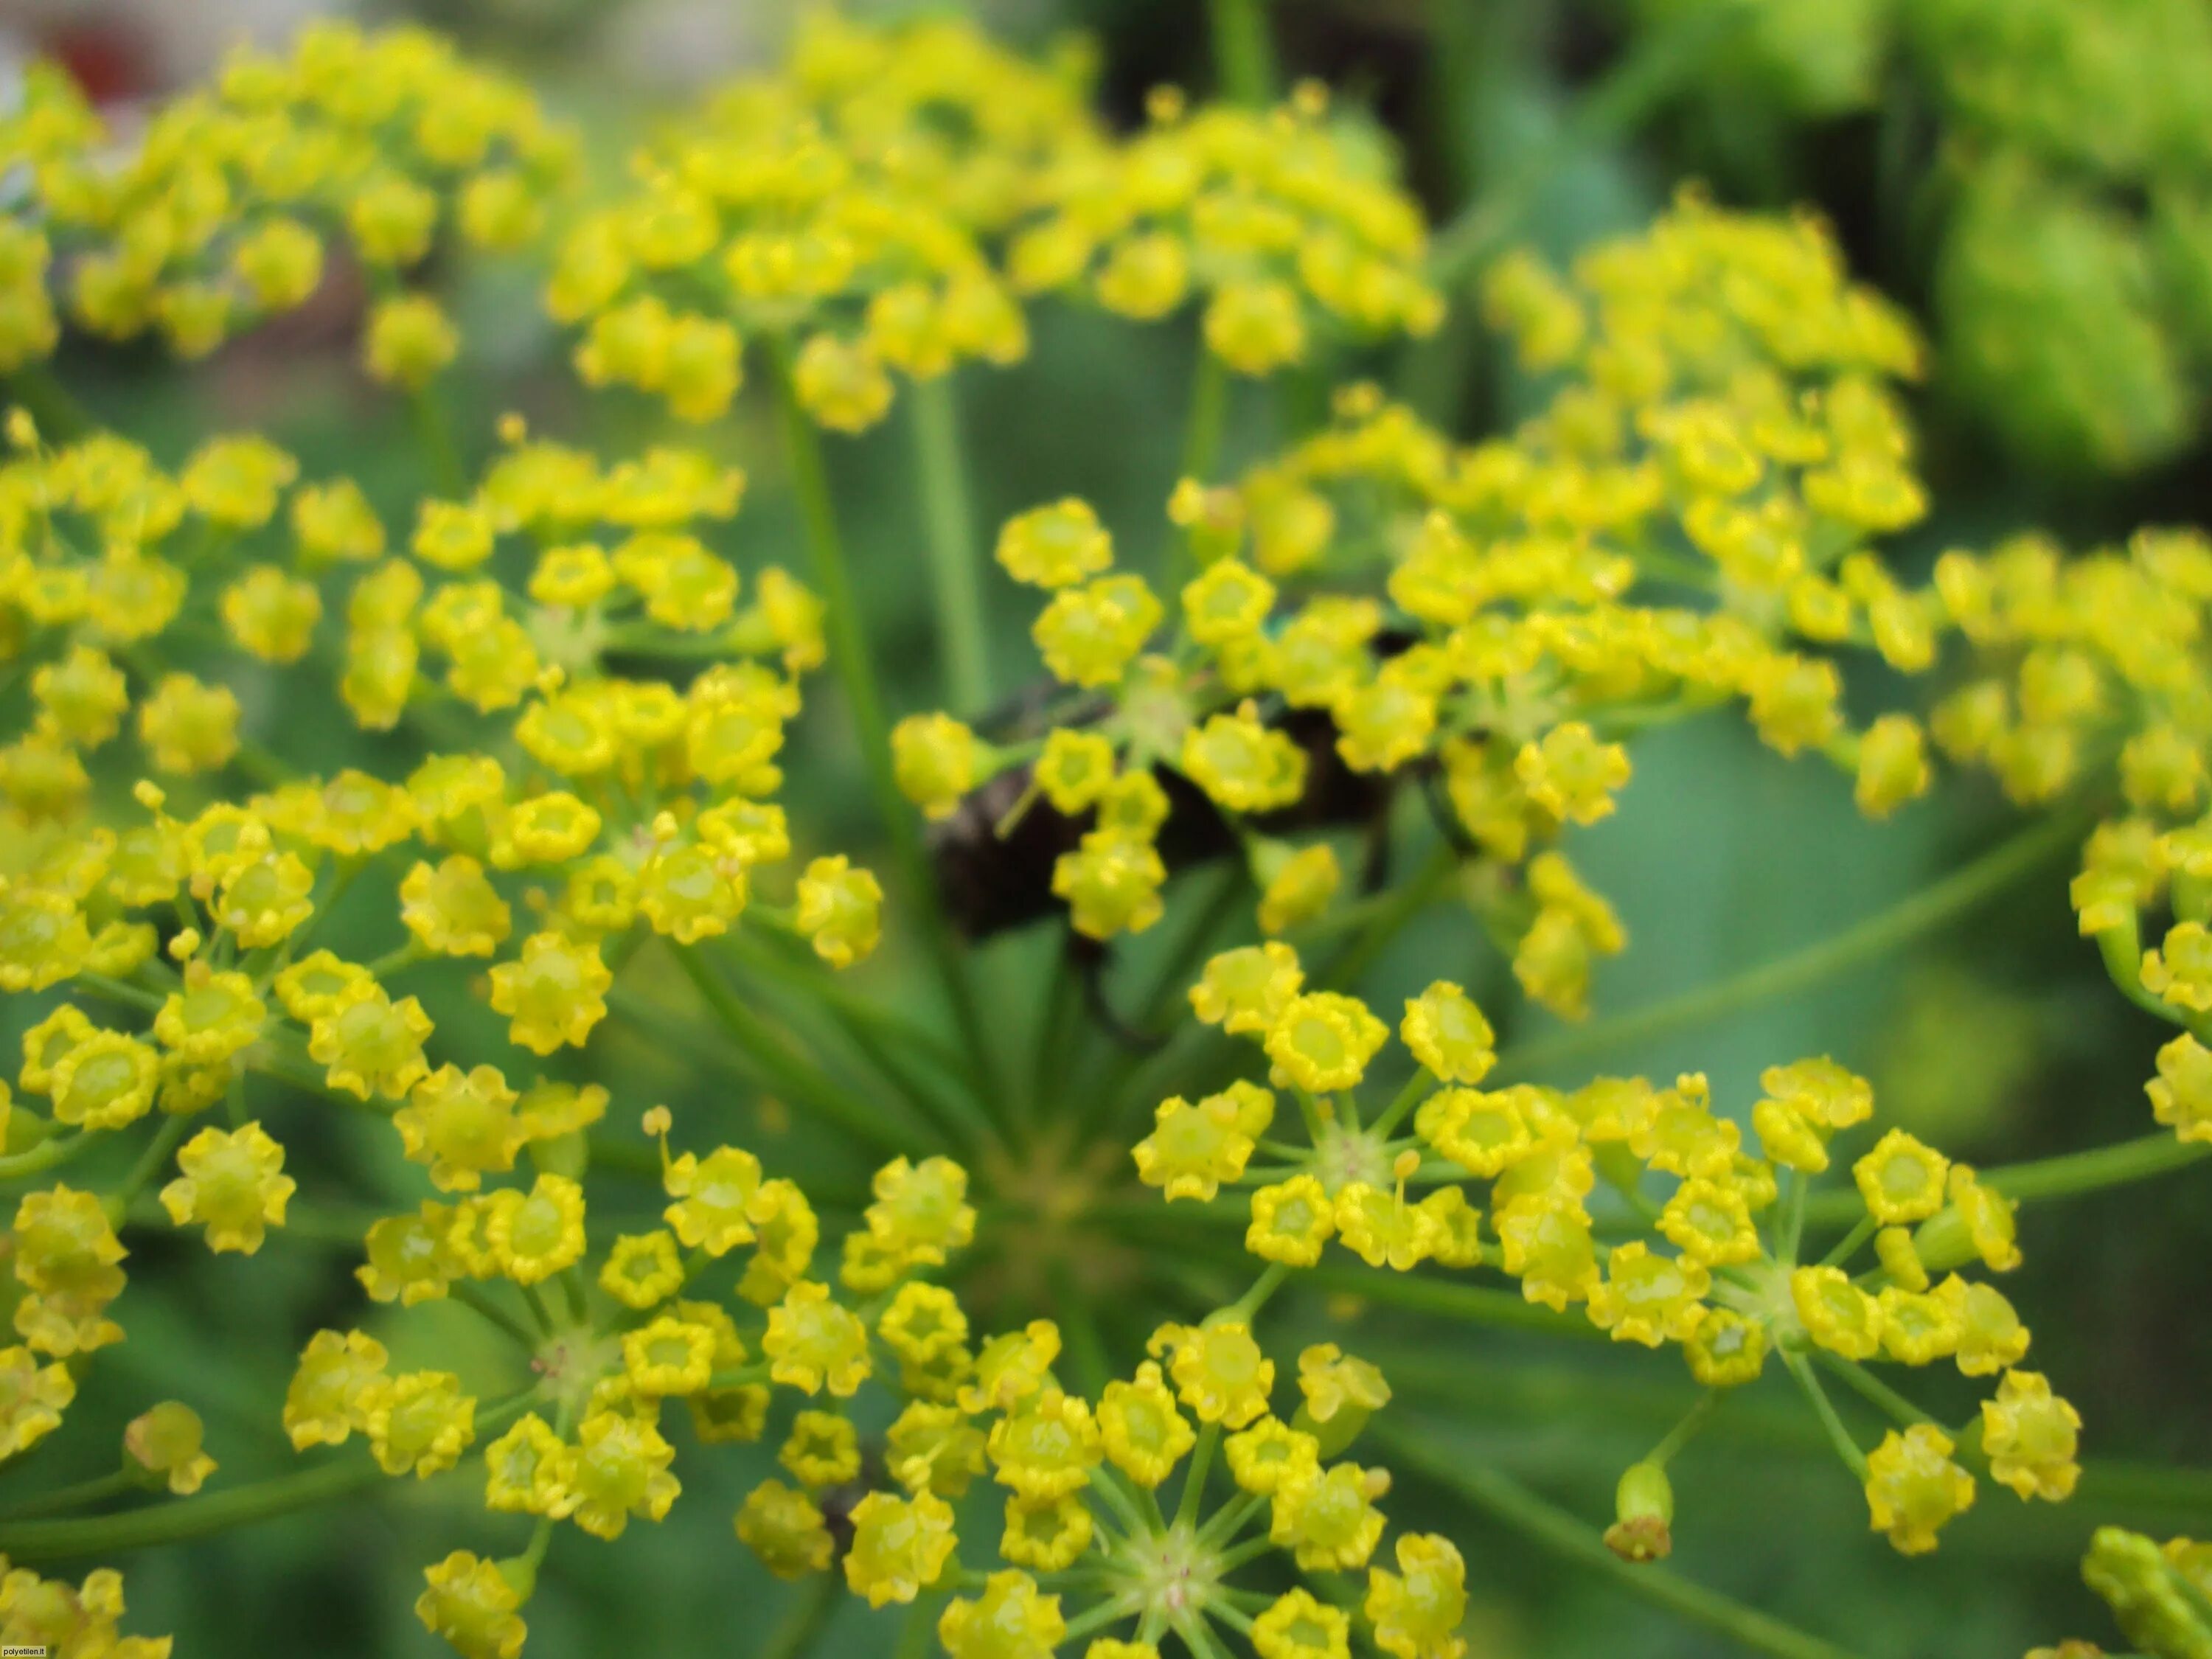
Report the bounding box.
[1135,942,2081,1553]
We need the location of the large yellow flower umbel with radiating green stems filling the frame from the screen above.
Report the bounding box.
[0,0,2212,1659]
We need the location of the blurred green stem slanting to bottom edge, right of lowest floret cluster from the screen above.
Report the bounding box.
[1367,1420,1851,1659]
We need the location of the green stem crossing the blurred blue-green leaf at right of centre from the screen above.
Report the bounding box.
[1495,814,2081,1079]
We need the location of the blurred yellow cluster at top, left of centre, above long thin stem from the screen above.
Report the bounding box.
[546,15,1091,431]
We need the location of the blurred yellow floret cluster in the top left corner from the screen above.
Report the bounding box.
[0,24,575,387]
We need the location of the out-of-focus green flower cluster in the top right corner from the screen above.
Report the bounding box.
[1637,0,2212,471]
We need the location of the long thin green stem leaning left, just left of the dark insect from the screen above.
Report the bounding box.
[772,338,1004,1121]
